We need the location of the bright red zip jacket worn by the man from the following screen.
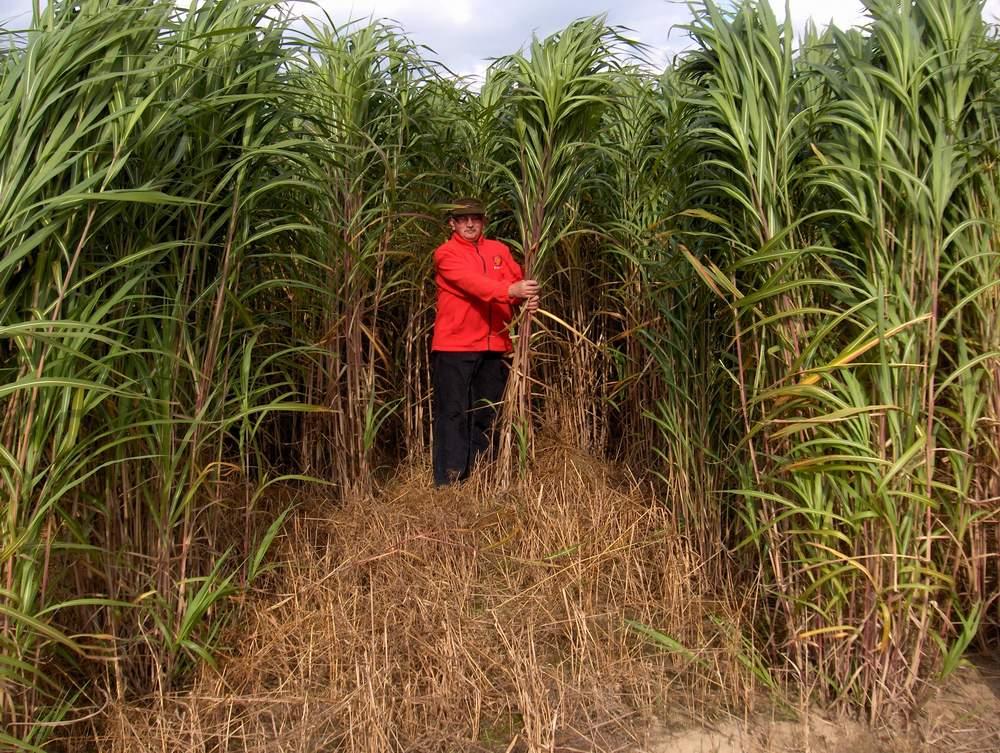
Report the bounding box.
[431,233,524,353]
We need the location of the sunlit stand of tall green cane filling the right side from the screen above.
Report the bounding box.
[687,0,996,717]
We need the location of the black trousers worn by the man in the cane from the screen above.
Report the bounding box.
[431,351,510,486]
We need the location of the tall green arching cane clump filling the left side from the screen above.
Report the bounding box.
[0,2,320,747]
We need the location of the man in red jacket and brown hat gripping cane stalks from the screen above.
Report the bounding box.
[431,198,539,486]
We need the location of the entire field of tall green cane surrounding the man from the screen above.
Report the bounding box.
[0,0,1000,750]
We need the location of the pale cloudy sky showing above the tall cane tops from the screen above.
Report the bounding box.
[0,0,1000,75]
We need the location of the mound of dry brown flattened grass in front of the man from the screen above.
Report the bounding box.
[80,444,748,753]
